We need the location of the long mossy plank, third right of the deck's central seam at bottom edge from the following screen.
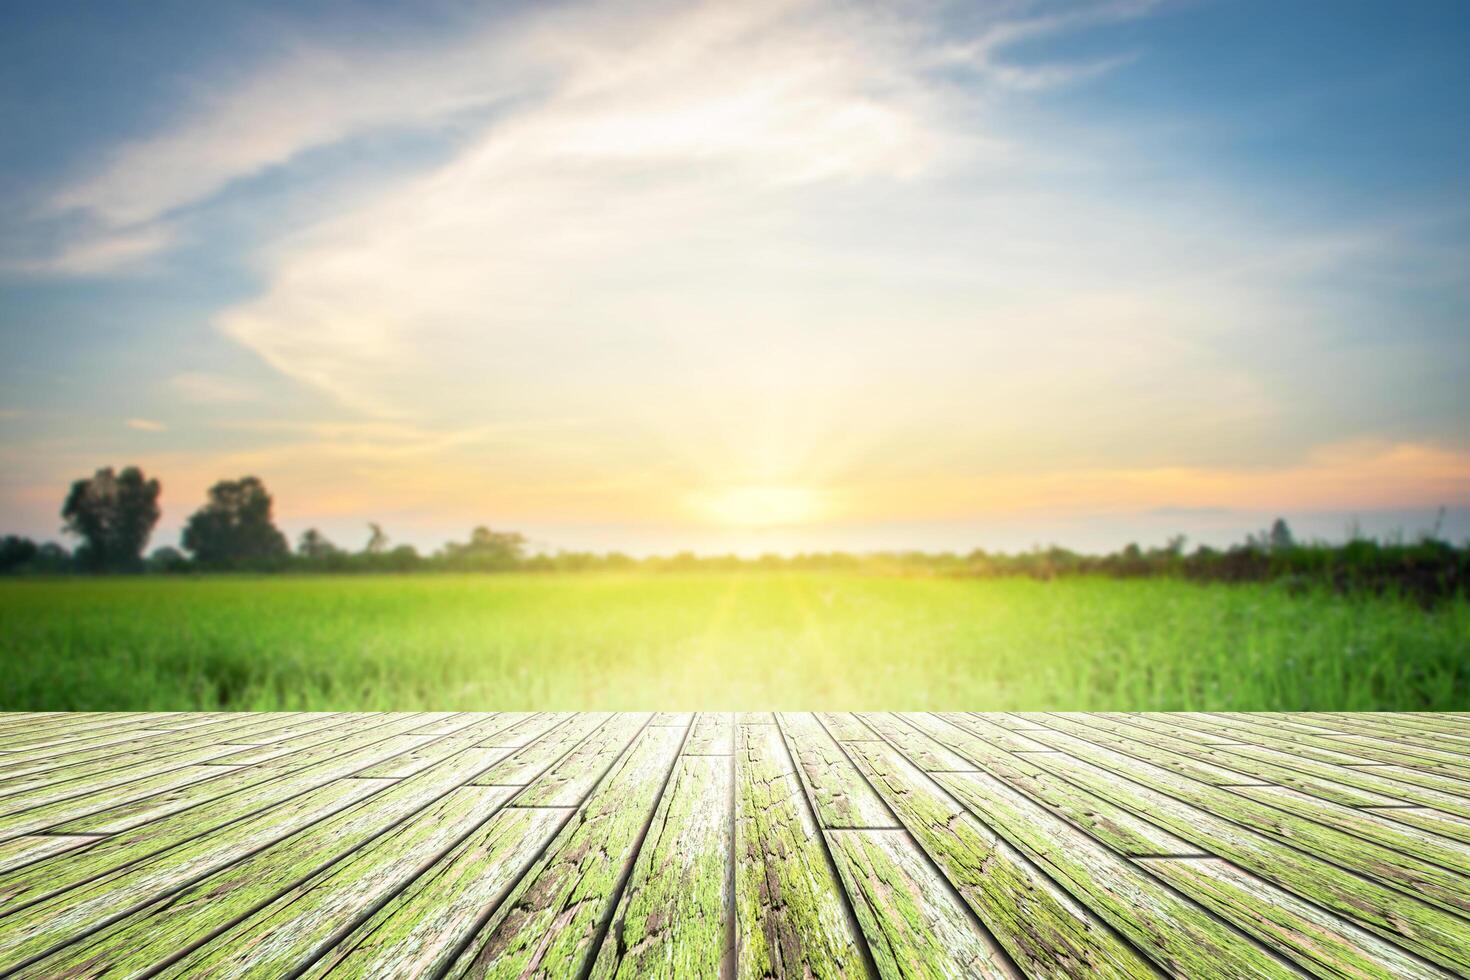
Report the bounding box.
[851,742,1154,977]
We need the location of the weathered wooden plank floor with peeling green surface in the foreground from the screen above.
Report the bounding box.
[0,713,1470,979]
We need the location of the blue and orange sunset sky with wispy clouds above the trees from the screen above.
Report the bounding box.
[0,0,1470,552]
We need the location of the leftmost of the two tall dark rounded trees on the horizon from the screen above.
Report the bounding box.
[62,466,162,572]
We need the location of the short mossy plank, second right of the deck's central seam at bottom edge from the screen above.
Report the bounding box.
[823,830,1020,977]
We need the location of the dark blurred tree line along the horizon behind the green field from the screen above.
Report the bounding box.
[0,467,1470,602]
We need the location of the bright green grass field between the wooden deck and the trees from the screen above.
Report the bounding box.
[0,573,1470,710]
